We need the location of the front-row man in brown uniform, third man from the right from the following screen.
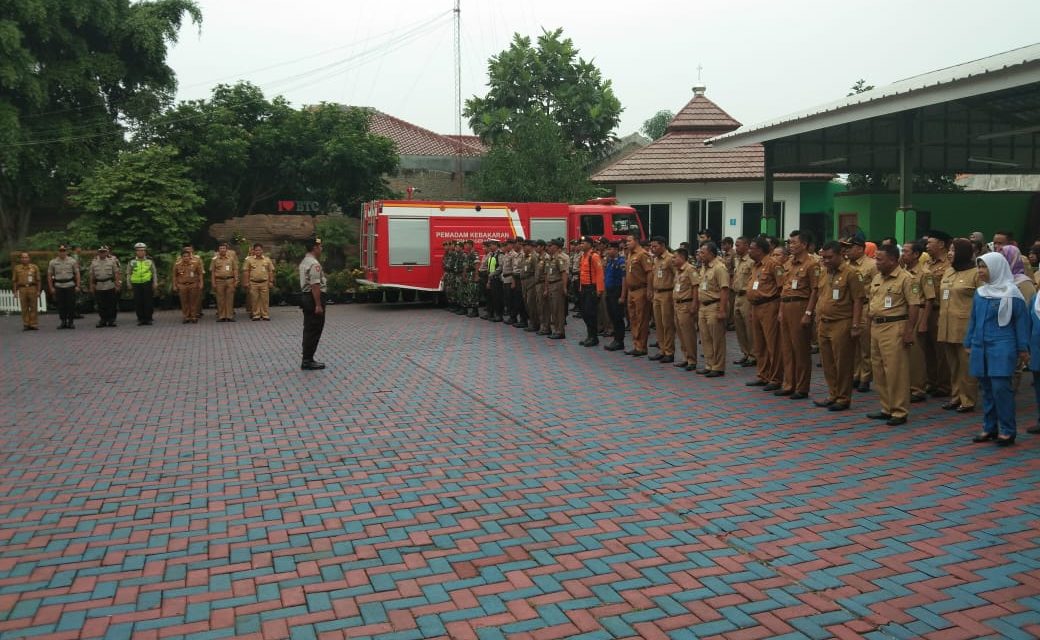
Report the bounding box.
[773,230,821,400]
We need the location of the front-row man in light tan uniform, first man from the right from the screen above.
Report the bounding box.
[866,245,920,427]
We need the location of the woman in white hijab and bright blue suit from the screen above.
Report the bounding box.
[964,253,1030,446]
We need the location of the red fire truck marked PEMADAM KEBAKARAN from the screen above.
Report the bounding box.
[359,198,643,291]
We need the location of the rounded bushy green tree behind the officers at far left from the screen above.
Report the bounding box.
[70,147,205,252]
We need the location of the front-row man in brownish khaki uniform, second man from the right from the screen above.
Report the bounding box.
[812,240,866,411]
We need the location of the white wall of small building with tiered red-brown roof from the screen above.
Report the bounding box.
[617,181,802,247]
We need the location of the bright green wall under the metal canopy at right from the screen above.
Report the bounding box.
[833,191,1034,240]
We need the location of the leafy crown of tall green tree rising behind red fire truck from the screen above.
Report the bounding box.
[463,29,621,159]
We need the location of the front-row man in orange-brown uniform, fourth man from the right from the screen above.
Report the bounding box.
[747,236,783,391]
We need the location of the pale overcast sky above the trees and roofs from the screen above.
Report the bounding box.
[168,0,1040,135]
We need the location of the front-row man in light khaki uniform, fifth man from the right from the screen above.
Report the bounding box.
[694,242,729,378]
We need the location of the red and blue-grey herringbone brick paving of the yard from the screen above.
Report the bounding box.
[0,305,1040,640]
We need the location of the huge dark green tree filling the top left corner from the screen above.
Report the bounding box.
[0,0,202,248]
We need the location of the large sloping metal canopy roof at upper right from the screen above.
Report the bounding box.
[705,43,1040,174]
